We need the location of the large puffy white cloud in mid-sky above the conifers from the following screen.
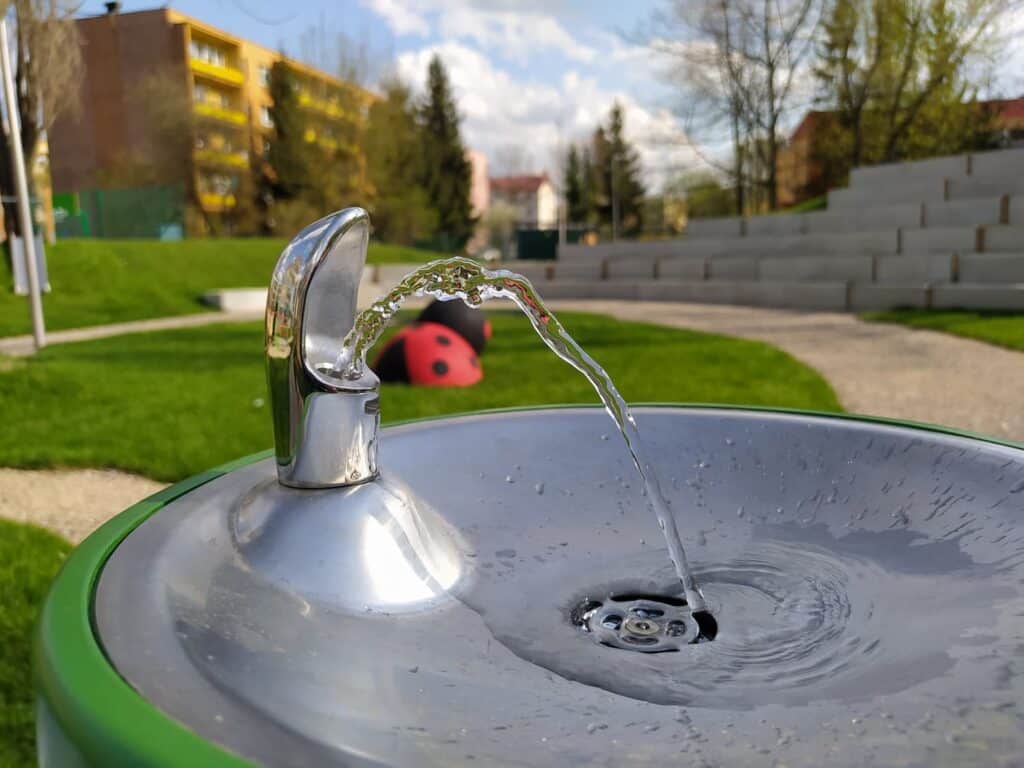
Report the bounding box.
[398,42,696,188]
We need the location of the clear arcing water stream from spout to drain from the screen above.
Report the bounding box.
[335,257,713,622]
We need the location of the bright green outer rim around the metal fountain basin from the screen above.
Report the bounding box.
[33,402,1024,768]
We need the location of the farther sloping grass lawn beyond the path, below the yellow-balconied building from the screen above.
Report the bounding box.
[0,238,443,336]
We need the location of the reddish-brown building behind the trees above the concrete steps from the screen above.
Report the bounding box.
[778,97,1024,208]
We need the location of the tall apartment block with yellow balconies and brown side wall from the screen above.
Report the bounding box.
[49,3,373,234]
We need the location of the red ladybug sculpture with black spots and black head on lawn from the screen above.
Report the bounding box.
[373,323,483,387]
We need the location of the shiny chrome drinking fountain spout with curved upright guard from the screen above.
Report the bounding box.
[265,208,380,488]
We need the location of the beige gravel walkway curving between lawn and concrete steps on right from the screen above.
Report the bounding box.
[553,300,1024,442]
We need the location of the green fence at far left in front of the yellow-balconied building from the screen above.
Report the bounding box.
[53,185,184,240]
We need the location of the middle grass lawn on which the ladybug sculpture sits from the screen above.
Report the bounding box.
[0,312,839,481]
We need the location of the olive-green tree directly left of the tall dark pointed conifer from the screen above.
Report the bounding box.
[364,80,437,245]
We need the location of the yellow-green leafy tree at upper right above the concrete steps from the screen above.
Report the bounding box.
[815,0,1009,176]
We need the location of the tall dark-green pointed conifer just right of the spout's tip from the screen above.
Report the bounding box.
[419,54,476,251]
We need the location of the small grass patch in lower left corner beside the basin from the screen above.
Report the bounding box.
[0,520,71,768]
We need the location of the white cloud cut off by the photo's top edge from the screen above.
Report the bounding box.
[361,0,597,61]
